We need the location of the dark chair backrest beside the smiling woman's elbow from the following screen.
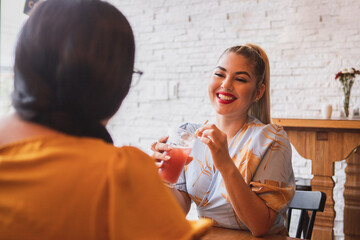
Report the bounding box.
[287,190,326,239]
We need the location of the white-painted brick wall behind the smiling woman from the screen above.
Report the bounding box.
[0,0,360,239]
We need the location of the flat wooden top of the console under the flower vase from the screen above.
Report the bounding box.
[272,118,360,130]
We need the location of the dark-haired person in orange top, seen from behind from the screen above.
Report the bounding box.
[0,0,209,239]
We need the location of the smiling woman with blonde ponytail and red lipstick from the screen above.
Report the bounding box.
[152,44,295,236]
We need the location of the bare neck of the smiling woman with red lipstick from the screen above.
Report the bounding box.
[216,115,248,144]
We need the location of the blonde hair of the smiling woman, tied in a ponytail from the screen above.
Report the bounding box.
[221,43,271,124]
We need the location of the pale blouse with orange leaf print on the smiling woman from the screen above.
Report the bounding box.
[176,116,295,233]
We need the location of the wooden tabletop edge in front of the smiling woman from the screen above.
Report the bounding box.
[202,227,298,240]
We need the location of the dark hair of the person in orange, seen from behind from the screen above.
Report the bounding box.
[12,0,135,142]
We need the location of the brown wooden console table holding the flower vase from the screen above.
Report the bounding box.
[272,118,360,240]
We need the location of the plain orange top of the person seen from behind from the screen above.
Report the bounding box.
[0,134,210,240]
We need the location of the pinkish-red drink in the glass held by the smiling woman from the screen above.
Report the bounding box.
[159,147,191,184]
